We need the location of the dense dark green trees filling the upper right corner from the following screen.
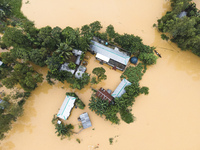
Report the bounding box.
[157,0,200,56]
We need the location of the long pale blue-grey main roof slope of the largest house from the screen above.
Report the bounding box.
[90,40,130,65]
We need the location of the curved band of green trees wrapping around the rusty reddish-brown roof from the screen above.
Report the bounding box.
[89,64,149,124]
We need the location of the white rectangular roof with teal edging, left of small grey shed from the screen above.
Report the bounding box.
[57,95,76,120]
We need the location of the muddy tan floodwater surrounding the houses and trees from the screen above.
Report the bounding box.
[0,0,200,150]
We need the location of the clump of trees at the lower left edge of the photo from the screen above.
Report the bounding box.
[0,90,30,140]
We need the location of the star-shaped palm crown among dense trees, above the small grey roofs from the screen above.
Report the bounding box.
[56,43,73,61]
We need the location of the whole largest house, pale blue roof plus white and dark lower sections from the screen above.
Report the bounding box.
[90,40,130,71]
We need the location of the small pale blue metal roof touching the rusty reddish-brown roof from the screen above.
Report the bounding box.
[112,79,131,98]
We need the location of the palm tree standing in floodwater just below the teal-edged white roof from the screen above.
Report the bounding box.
[55,123,74,139]
